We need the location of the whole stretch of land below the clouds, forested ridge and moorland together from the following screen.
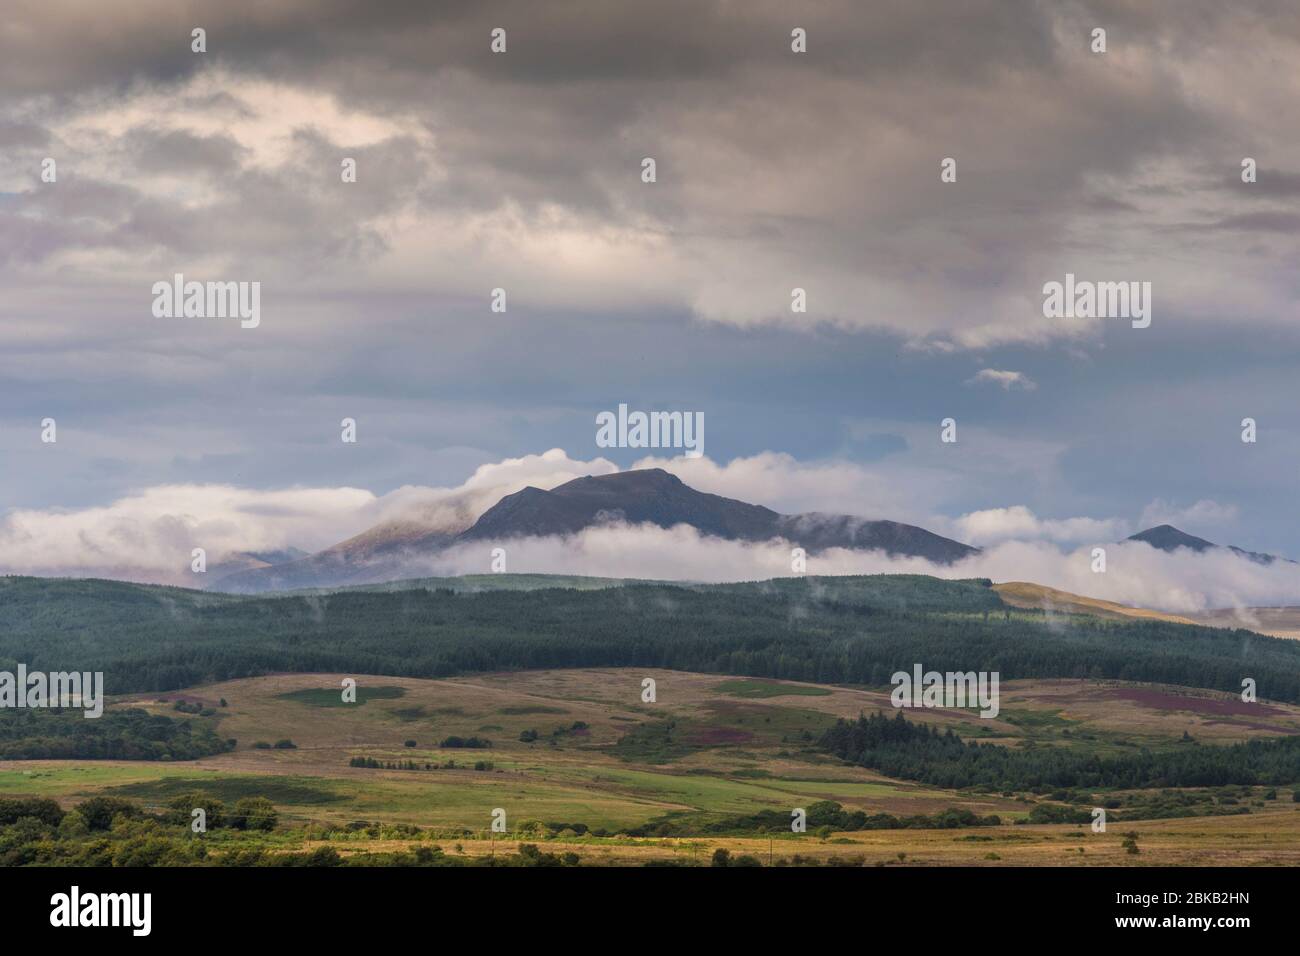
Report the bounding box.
[0,576,1300,865]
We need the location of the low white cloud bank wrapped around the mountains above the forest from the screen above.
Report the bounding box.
[0,449,1300,611]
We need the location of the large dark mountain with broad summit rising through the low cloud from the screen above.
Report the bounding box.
[215,468,978,593]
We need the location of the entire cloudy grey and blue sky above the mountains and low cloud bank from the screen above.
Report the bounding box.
[0,0,1300,582]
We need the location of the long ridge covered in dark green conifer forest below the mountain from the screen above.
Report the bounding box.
[0,575,1300,701]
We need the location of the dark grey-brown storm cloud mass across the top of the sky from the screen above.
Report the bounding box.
[0,0,1291,339]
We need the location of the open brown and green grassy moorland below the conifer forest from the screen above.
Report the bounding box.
[0,669,1300,865]
